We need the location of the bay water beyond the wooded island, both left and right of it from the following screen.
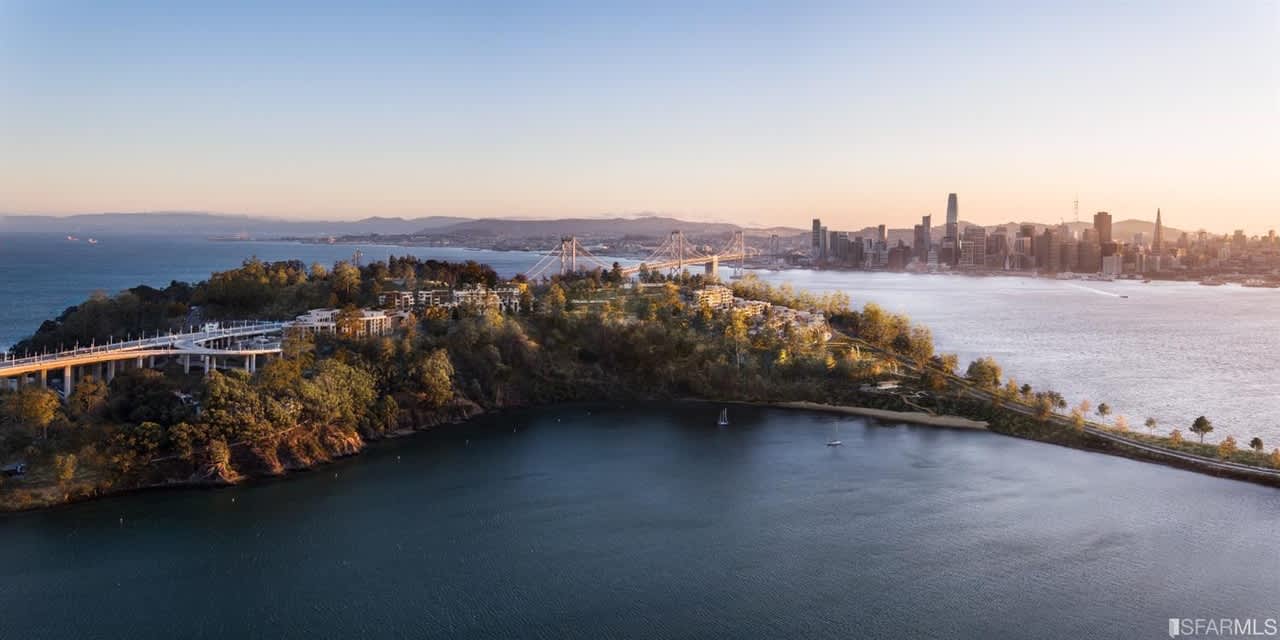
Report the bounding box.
[0,234,1280,448]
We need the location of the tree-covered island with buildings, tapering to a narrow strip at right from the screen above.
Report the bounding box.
[0,256,1280,511]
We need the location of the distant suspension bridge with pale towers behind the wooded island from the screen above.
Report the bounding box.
[525,230,756,280]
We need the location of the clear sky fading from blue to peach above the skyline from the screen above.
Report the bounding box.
[0,0,1280,233]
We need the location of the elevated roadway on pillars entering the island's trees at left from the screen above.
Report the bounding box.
[0,323,287,394]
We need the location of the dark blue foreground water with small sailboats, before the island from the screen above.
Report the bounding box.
[0,404,1280,640]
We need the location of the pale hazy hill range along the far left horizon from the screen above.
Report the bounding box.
[0,211,467,238]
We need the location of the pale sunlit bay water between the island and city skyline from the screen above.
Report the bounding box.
[760,271,1280,451]
